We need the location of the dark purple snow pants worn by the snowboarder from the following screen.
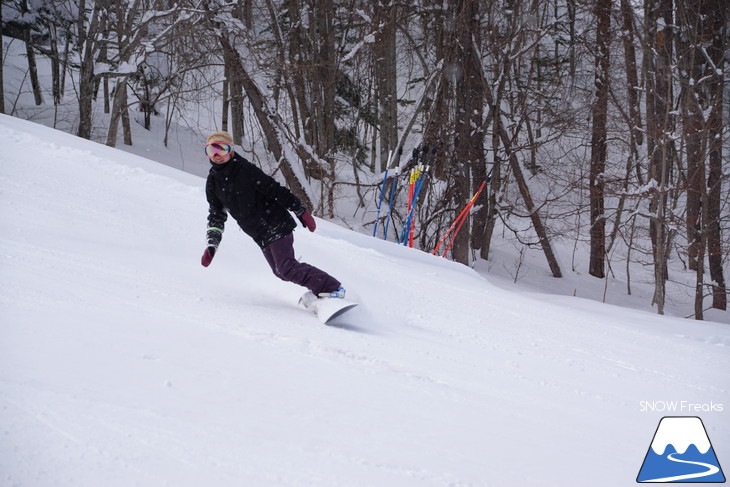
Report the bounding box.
[263,233,340,295]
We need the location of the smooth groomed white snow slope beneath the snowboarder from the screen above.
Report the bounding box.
[0,115,730,487]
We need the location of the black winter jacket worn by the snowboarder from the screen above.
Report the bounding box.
[205,153,306,252]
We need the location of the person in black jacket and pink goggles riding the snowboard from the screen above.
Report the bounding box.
[201,132,345,300]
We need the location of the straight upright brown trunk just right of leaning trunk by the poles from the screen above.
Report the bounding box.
[589,0,611,278]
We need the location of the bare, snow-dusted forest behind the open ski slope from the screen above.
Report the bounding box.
[0,0,730,319]
